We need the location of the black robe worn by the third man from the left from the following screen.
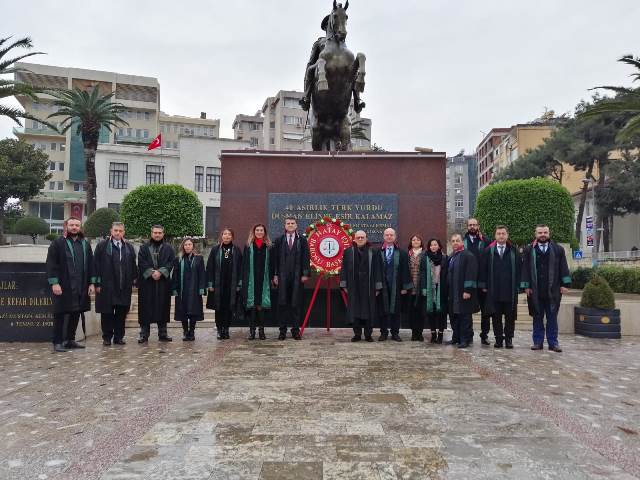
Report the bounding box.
[138,242,175,325]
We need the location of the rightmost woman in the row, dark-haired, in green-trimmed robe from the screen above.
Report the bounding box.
[420,238,449,344]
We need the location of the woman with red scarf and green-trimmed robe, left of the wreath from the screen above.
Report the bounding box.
[242,223,271,340]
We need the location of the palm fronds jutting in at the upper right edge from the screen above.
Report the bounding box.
[582,55,640,142]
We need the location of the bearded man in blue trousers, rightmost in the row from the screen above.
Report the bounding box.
[520,225,571,352]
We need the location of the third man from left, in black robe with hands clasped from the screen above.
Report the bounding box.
[138,225,175,343]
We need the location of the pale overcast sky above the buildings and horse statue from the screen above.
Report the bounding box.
[0,0,640,154]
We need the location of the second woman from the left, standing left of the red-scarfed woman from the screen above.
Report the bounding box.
[207,228,242,340]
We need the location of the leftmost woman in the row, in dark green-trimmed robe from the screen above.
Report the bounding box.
[171,237,207,342]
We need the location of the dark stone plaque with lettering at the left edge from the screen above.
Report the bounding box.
[0,271,53,342]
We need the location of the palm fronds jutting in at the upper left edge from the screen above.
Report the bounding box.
[0,37,56,130]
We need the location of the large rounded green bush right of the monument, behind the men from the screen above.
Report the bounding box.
[475,178,575,245]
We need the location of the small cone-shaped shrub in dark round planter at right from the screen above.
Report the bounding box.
[574,275,620,338]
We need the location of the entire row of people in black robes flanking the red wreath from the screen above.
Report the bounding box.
[47,218,571,352]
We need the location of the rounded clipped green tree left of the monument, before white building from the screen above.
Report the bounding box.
[120,185,203,237]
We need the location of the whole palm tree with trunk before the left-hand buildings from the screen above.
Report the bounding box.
[48,85,129,216]
